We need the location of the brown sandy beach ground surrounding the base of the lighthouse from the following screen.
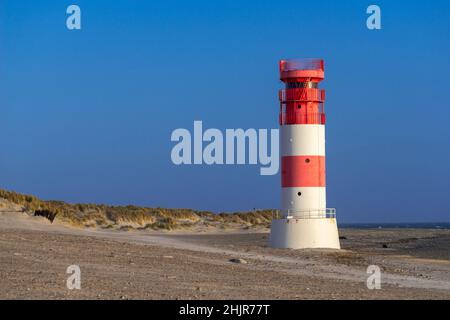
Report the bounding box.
[0,211,450,299]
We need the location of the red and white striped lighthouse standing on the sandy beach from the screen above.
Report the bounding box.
[270,59,340,249]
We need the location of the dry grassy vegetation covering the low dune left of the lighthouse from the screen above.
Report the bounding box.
[0,189,272,230]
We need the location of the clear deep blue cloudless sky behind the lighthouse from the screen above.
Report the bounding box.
[0,0,450,222]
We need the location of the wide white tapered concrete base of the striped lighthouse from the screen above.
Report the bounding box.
[270,217,341,249]
